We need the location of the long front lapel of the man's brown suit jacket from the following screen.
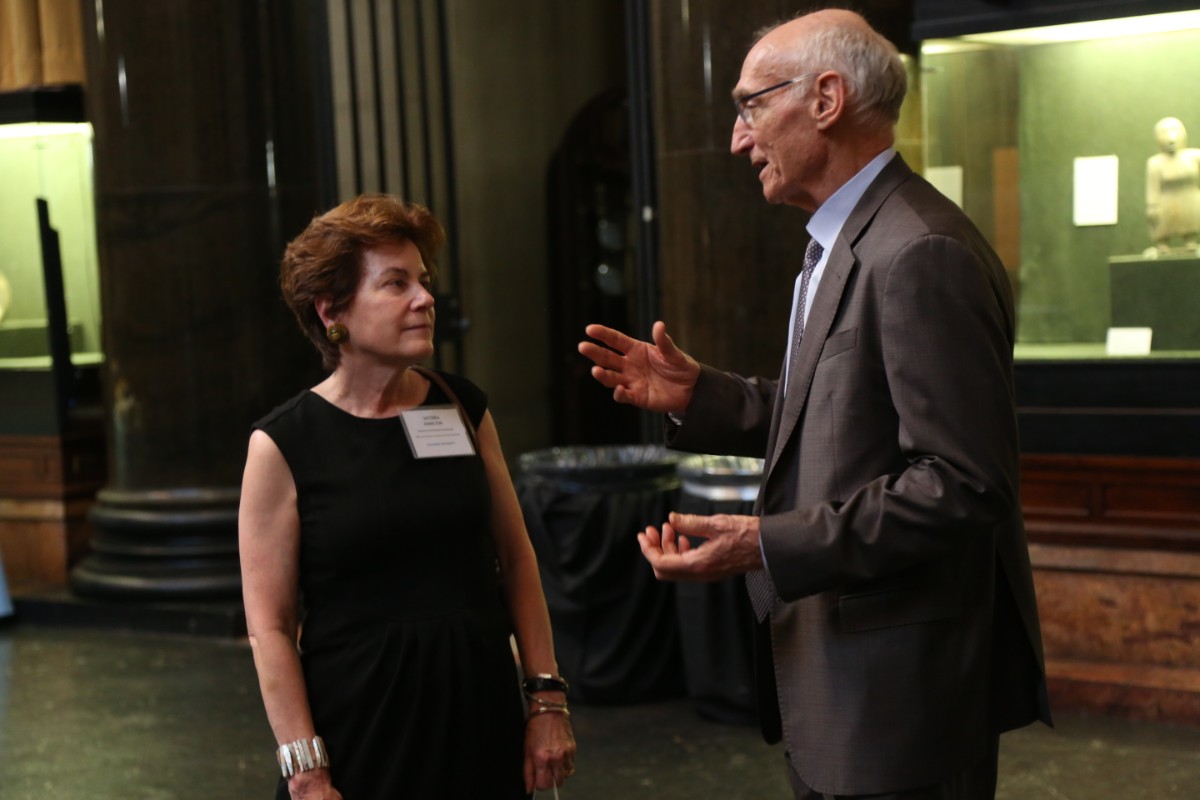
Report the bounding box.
[760,155,912,484]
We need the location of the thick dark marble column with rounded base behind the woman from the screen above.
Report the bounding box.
[71,0,318,599]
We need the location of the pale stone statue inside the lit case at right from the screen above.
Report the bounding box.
[1145,116,1200,257]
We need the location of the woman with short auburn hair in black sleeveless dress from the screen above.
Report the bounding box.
[239,194,575,800]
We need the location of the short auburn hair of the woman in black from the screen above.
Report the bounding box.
[280,194,446,369]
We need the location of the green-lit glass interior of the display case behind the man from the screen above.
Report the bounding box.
[920,4,1200,362]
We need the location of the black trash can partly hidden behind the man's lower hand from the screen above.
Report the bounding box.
[676,456,762,724]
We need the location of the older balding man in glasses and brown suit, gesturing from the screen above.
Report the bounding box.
[580,10,1050,800]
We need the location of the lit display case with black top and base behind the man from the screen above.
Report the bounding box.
[913,0,1200,458]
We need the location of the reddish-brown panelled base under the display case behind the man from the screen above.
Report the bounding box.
[1021,456,1200,723]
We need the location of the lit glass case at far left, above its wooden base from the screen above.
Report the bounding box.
[0,86,103,434]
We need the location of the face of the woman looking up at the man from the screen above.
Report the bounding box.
[337,241,433,366]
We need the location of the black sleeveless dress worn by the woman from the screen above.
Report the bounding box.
[254,373,527,800]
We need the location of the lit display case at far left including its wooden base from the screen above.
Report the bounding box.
[0,85,106,587]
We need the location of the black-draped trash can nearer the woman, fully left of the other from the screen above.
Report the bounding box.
[516,445,684,704]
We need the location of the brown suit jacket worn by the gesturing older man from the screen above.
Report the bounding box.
[668,156,1050,794]
